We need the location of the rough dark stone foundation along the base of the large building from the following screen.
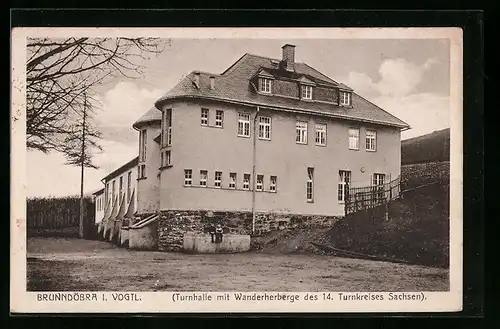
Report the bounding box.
[158,210,340,251]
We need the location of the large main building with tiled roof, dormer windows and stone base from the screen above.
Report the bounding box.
[98,44,409,250]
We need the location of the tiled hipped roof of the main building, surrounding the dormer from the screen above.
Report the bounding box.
[155,54,409,128]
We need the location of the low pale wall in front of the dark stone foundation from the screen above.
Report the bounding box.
[183,232,250,253]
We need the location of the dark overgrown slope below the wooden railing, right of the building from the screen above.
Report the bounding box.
[328,162,450,267]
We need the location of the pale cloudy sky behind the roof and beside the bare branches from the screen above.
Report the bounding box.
[27,39,450,197]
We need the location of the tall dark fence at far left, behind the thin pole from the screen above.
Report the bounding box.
[26,197,95,236]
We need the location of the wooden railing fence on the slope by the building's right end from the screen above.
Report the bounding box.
[345,176,401,215]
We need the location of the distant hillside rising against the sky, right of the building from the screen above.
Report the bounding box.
[401,128,450,165]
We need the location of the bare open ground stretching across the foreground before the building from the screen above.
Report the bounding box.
[27,238,449,291]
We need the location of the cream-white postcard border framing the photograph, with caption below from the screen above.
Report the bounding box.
[10,28,463,313]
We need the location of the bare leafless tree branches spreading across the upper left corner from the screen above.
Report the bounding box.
[26,37,166,153]
